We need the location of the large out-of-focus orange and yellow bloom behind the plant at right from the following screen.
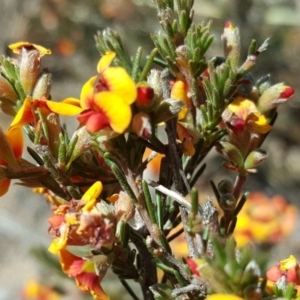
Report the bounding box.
[234,193,298,247]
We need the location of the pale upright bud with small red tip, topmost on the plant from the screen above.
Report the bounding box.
[221,21,241,68]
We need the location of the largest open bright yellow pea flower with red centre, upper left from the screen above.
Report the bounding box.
[65,52,137,133]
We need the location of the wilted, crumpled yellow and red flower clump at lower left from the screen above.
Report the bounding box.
[48,181,115,300]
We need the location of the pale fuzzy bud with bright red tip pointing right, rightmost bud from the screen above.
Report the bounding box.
[257,83,295,114]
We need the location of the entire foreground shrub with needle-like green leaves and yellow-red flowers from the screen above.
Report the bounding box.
[0,0,297,299]
